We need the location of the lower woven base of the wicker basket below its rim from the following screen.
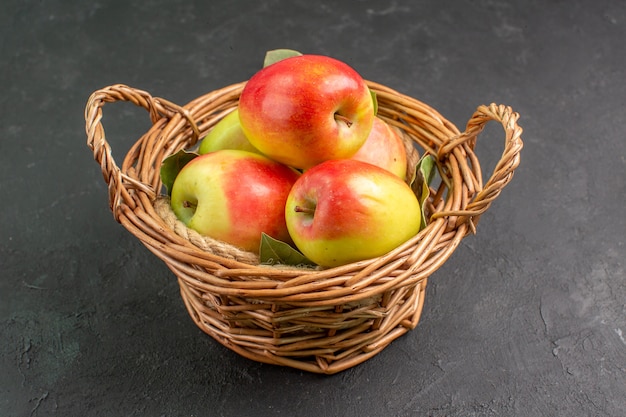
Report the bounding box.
[179,279,427,375]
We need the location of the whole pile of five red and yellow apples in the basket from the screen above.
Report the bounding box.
[163,53,422,267]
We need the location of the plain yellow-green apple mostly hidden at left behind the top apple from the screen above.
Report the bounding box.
[198,108,259,154]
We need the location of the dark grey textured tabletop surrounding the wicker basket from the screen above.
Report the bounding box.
[0,0,626,417]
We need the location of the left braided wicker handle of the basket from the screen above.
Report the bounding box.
[85,84,199,216]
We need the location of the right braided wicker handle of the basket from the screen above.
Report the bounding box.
[432,103,523,233]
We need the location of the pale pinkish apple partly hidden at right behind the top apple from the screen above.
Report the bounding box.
[351,117,407,180]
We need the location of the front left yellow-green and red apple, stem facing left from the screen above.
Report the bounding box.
[170,149,300,253]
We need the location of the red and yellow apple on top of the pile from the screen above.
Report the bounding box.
[239,54,375,169]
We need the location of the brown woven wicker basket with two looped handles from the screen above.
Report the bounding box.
[85,82,522,374]
